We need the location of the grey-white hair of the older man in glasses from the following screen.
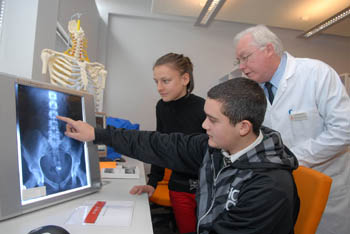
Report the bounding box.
[233,24,284,57]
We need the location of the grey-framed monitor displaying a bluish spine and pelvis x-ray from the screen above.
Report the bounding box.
[0,74,101,220]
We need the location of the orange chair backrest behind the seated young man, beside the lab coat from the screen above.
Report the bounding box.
[293,166,332,234]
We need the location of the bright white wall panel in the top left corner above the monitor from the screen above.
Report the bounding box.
[0,0,39,78]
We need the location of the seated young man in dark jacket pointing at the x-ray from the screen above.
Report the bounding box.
[57,78,299,234]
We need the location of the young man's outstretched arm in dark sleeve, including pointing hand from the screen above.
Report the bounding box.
[57,116,208,174]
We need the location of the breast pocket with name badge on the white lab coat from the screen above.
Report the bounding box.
[289,109,323,142]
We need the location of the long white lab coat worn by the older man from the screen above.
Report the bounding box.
[264,53,350,234]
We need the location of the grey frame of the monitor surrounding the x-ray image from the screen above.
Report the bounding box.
[0,74,101,220]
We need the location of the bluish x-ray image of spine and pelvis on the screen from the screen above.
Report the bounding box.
[16,84,90,201]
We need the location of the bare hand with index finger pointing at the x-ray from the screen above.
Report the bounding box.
[57,116,95,141]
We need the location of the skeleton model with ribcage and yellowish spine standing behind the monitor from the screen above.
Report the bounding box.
[41,19,107,112]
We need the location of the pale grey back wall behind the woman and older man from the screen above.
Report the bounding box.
[104,14,350,130]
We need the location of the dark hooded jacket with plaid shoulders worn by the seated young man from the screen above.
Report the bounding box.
[95,127,299,234]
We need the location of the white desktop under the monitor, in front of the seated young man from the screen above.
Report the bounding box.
[0,156,153,234]
